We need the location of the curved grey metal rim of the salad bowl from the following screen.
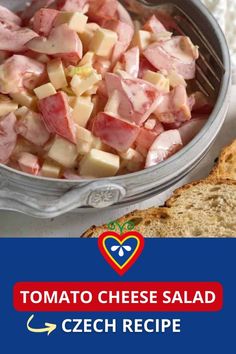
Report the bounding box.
[0,0,231,186]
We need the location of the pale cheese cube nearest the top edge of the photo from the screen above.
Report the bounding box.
[54,12,88,33]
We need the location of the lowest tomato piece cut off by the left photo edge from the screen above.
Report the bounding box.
[0,113,17,163]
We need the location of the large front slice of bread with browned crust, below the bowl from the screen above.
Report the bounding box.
[83,180,236,237]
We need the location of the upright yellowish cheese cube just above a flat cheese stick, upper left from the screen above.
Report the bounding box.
[47,59,67,90]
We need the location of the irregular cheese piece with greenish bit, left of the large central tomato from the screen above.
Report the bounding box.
[71,70,102,96]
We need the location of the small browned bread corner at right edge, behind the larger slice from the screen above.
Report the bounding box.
[209,140,236,180]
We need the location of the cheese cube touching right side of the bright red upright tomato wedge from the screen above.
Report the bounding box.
[72,97,93,127]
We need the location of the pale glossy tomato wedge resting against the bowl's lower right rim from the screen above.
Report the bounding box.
[145,129,183,168]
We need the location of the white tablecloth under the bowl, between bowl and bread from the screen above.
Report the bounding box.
[0,86,236,237]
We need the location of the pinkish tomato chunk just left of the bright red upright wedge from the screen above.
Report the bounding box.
[16,111,50,146]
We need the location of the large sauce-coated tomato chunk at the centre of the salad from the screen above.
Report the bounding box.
[105,73,159,125]
